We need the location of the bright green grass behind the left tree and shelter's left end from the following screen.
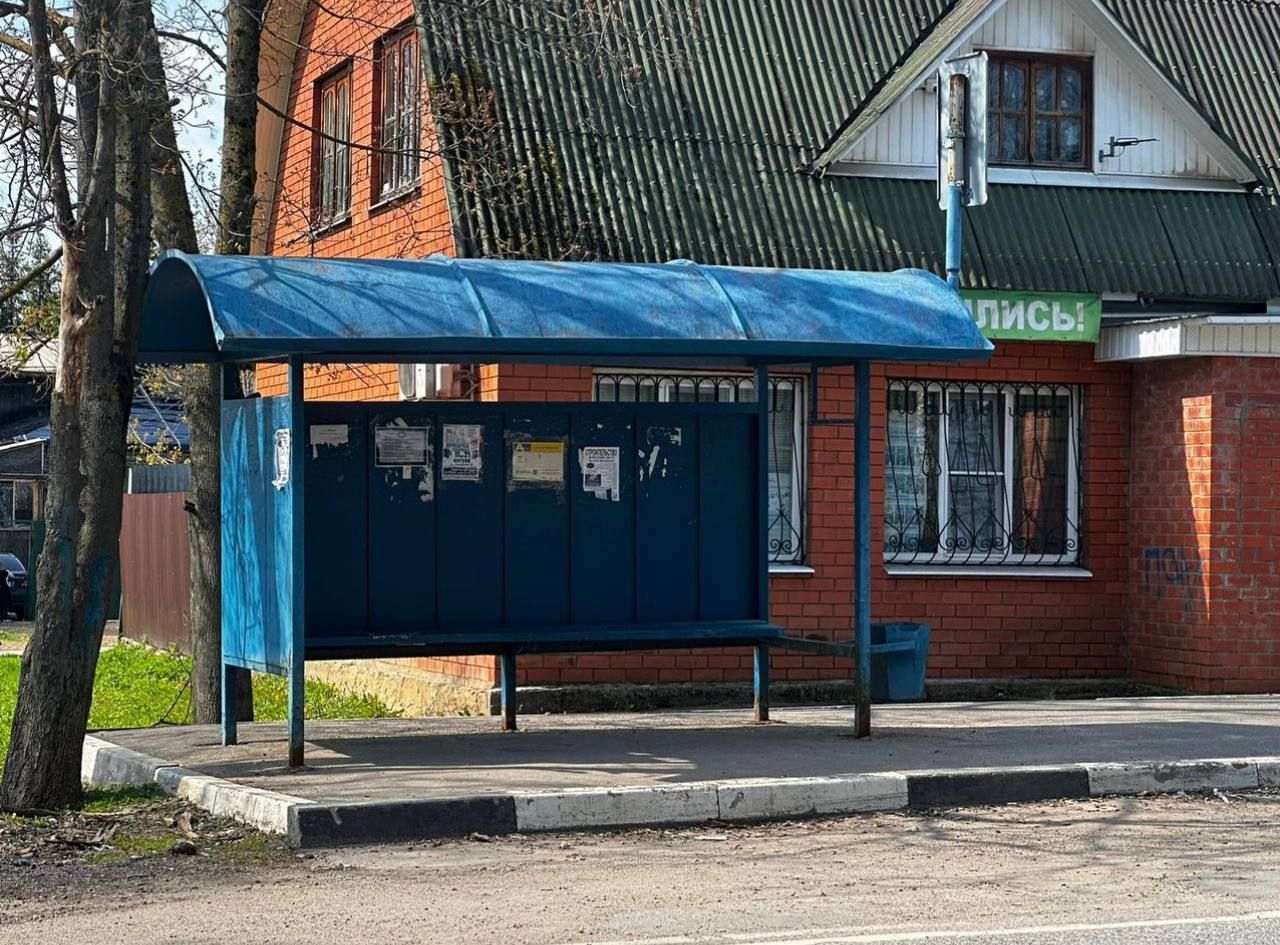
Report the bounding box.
[0,644,399,771]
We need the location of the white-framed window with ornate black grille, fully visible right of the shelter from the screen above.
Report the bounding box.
[884,380,1082,566]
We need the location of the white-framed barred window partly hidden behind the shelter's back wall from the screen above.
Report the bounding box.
[591,371,806,565]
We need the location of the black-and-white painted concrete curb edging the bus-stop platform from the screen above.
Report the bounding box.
[81,735,1280,848]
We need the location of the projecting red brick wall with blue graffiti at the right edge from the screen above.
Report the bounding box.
[1128,359,1280,693]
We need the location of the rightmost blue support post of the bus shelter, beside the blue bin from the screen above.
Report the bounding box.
[854,361,872,738]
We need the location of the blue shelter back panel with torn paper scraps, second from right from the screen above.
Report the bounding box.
[636,410,696,624]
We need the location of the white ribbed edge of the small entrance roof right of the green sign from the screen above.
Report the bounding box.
[1093,315,1280,361]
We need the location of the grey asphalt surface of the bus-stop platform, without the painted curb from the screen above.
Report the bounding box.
[94,697,1280,803]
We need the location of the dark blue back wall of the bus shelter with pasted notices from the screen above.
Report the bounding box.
[305,402,767,645]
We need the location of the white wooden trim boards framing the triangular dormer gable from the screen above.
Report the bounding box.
[814,0,1258,190]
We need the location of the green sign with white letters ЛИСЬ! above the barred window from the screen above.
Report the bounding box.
[960,289,1102,342]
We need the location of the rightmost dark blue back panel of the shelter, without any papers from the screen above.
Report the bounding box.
[698,414,760,620]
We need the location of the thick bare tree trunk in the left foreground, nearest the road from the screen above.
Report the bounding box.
[0,0,151,811]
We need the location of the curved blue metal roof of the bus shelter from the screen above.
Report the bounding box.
[140,252,992,365]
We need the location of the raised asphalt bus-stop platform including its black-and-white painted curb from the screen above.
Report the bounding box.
[86,697,1280,844]
